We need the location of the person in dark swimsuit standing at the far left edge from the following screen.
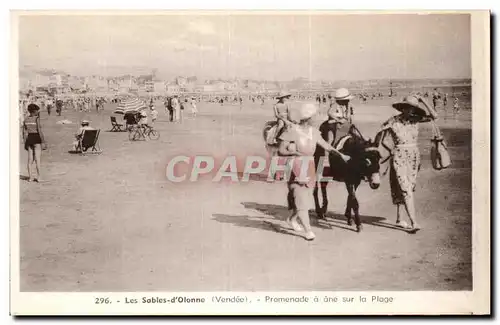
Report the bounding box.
[23,104,47,182]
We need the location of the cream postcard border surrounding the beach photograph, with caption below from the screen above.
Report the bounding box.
[10,11,491,315]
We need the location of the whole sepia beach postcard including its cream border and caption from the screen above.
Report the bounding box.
[9,10,491,316]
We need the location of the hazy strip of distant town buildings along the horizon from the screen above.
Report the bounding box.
[19,71,471,94]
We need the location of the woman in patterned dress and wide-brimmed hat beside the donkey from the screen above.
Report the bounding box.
[382,95,437,232]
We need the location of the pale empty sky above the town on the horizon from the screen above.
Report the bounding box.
[19,12,471,81]
